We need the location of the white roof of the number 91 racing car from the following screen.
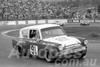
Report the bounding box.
[20,24,59,30]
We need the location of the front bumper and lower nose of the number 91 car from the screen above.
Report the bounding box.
[57,46,87,58]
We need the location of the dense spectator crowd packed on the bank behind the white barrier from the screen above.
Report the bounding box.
[0,0,99,20]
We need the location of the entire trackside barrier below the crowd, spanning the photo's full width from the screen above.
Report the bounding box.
[0,19,100,26]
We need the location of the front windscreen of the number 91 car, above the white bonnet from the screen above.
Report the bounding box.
[41,26,65,39]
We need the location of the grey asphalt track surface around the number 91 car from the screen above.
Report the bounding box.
[0,23,100,67]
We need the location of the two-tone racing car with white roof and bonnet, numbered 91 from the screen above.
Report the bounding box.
[12,24,88,62]
